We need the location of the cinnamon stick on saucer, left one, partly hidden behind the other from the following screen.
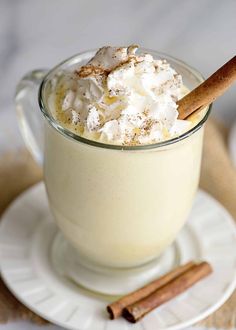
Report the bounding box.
[107,261,196,320]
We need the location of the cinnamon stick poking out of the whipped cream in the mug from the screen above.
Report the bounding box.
[177,56,236,119]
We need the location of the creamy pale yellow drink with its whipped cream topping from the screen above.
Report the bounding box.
[44,46,207,267]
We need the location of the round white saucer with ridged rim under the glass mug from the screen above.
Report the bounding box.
[0,183,236,330]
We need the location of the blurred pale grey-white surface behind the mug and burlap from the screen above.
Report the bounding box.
[0,0,236,330]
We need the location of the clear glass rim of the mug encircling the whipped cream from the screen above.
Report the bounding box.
[38,48,212,151]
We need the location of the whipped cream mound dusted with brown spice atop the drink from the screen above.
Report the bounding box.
[56,45,191,145]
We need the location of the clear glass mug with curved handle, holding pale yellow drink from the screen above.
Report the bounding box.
[16,49,209,288]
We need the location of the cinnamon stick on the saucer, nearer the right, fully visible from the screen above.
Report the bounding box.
[122,262,212,323]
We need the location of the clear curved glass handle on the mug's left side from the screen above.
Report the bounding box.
[15,69,48,166]
